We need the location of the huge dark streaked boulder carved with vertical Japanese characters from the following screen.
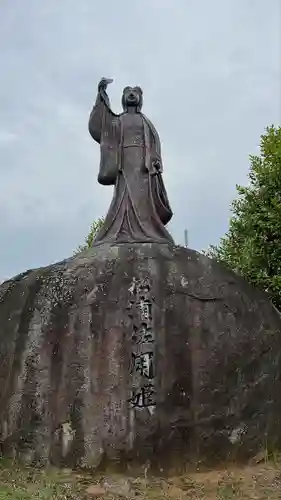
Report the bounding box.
[0,244,281,468]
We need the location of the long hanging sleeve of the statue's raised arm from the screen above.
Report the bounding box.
[89,91,120,185]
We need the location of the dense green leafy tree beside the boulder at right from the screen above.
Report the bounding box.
[207,126,281,309]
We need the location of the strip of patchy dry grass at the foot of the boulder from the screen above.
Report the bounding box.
[0,460,281,500]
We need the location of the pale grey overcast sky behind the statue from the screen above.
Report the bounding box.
[0,0,281,281]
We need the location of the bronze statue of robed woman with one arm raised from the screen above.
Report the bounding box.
[89,78,173,245]
